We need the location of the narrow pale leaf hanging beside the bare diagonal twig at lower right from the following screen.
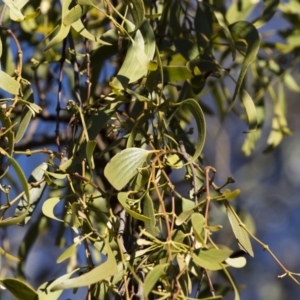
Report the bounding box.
[226,204,254,256]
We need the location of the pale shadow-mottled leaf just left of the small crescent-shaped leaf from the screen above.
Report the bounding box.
[15,163,48,225]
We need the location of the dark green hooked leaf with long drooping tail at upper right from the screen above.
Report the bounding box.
[229,21,260,109]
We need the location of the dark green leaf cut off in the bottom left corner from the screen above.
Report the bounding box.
[0,278,40,300]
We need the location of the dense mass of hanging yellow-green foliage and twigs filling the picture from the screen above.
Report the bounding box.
[0,0,300,300]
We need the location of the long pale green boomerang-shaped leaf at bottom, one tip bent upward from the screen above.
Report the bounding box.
[51,241,118,291]
